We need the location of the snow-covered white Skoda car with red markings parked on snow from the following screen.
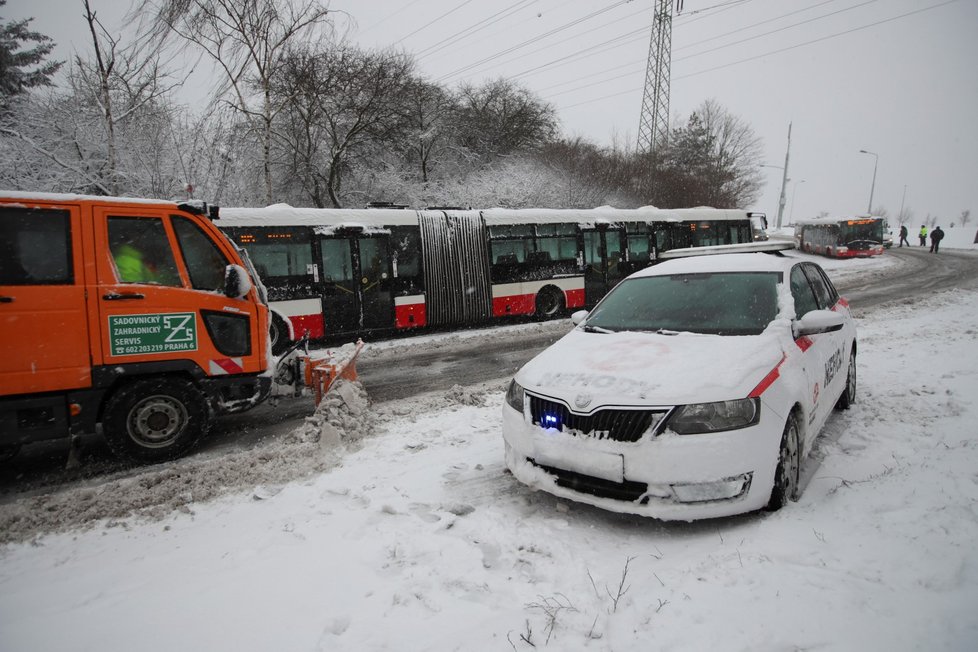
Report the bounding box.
[502,243,856,520]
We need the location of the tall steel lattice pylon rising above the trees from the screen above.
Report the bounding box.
[638,0,683,154]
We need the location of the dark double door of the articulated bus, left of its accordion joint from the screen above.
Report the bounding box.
[319,232,394,335]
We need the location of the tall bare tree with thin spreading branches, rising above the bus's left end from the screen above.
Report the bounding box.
[140,0,333,203]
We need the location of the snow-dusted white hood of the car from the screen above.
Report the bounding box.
[516,327,783,410]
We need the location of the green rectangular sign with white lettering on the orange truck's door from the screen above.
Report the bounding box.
[109,312,197,355]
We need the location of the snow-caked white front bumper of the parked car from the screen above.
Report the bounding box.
[503,402,784,520]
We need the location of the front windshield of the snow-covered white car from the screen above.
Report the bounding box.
[584,272,781,335]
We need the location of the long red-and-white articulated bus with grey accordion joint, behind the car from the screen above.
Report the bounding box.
[216,206,757,351]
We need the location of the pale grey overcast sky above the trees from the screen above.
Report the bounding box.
[7,0,978,225]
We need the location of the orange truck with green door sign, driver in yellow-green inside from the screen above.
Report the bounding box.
[0,191,274,463]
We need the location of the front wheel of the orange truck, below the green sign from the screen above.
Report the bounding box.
[102,378,210,463]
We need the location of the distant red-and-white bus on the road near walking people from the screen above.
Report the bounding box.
[795,216,886,258]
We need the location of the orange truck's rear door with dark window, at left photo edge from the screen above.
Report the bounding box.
[0,205,91,395]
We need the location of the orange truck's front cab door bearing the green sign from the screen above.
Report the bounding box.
[94,205,264,375]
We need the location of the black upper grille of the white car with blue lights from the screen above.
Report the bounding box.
[527,394,666,441]
